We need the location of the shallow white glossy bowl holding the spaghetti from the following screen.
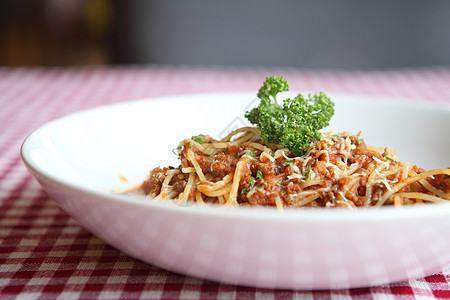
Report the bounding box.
[22,93,450,289]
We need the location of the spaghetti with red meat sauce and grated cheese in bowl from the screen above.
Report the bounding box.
[139,127,450,210]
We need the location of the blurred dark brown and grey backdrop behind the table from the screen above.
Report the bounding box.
[0,0,450,69]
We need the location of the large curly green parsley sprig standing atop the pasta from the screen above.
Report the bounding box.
[245,76,334,155]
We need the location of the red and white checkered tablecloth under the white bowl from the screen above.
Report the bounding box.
[0,66,450,299]
